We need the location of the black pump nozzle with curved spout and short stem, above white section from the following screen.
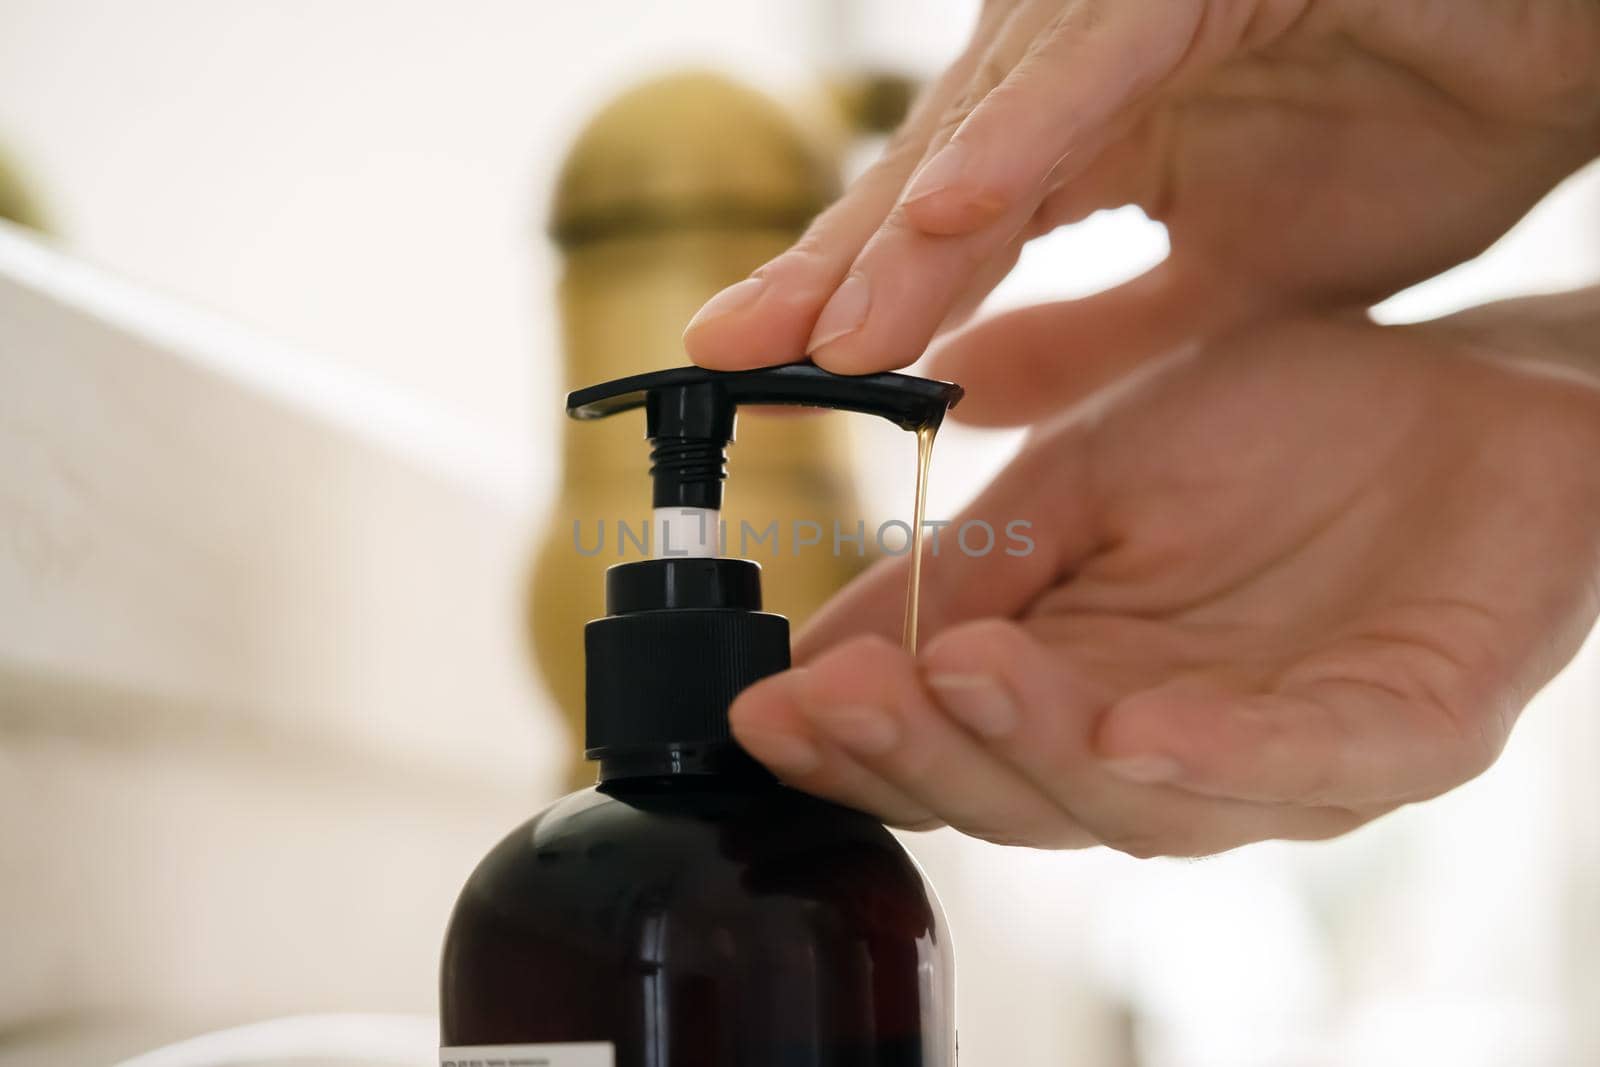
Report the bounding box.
[566,363,962,509]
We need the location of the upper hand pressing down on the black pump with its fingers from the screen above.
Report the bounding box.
[685,0,1600,374]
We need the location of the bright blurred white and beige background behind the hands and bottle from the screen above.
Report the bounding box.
[0,0,1600,1067]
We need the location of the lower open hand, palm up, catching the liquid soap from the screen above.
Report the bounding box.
[731,288,1600,856]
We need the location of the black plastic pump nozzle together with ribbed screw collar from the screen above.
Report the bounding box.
[566,363,962,781]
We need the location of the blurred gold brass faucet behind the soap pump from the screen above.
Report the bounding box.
[528,72,904,785]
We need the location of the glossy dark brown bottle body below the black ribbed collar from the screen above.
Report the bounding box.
[442,753,955,1067]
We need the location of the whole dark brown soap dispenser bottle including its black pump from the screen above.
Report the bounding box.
[440,365,960,1067]
